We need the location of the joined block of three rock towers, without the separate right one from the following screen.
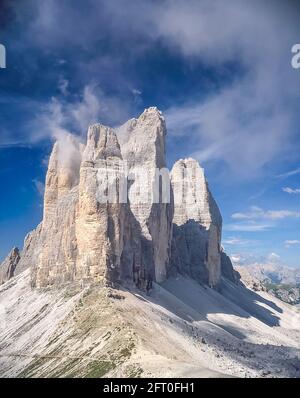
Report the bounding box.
[32,108,173,289]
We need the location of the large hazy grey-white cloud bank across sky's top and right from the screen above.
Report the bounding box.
[4,0,300,177]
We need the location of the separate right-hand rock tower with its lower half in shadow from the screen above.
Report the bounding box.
[171,158,222,287]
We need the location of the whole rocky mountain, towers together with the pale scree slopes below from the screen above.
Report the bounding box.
[0,107,300,378]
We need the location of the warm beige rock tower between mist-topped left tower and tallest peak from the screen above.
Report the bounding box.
[76,124,125,282]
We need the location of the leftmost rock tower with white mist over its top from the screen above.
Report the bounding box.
[32,135,83,287]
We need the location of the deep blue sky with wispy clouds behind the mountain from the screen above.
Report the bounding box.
[0,0,300,266]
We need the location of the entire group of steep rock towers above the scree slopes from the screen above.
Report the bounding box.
[1,108,234,290]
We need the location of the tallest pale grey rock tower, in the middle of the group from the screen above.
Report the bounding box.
[118,107,174,282]
